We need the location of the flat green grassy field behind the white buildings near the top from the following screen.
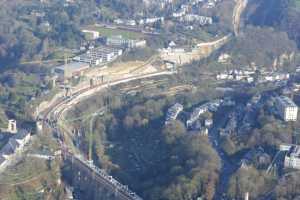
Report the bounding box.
[88,26,144,39]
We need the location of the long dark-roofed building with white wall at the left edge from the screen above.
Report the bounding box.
[0,130,31,170]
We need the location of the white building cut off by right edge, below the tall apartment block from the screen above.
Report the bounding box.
[284,145,300,169]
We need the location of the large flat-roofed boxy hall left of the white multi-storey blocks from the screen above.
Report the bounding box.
[54,62,90,80]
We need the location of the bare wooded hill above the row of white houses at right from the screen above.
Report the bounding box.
[224,26,297,69]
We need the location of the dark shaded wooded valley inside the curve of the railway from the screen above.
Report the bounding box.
[65,80,224,200]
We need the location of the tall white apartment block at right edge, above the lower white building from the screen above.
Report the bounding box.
[275,96,298,122]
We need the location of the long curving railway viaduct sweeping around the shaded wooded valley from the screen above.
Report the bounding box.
[34,71,176,200]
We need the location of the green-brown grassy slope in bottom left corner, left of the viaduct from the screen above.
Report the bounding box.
[0,135,64,200]
